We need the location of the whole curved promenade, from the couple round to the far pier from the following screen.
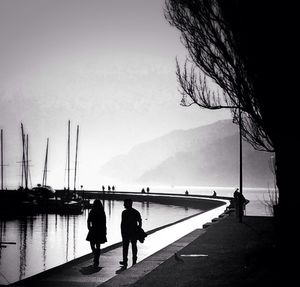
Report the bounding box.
[11,192,228,286]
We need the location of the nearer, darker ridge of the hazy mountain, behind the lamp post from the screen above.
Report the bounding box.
[139,135,274,187]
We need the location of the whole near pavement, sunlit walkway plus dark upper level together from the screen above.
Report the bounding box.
[9,200,278,287]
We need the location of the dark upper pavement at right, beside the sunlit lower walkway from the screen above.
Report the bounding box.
[125,213,278,287]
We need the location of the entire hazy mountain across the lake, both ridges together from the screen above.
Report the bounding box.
[100,120,274,187]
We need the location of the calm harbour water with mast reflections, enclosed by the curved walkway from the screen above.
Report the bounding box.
[0,201,203,284]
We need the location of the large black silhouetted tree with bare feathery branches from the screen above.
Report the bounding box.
[164,0,297,227]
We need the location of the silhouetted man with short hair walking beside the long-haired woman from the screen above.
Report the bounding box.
[120,199,142,268]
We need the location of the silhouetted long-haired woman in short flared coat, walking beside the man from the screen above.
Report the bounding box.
[86,199,107,267]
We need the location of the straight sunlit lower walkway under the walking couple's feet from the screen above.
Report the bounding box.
[11,199,226,287]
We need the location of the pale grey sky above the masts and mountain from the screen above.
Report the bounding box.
[0,0,230,189]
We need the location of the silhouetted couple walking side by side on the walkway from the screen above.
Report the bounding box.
[86,199,142,268]
